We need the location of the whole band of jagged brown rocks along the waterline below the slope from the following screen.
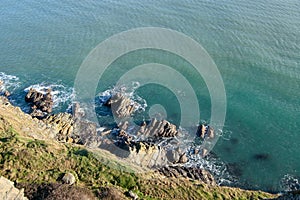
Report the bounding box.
[19,89,214,183]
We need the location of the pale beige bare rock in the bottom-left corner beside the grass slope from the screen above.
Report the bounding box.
[0,176,28,200]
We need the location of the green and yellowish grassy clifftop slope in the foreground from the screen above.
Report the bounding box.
[0,127,278,199]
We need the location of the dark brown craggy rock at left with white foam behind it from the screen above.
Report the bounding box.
[25,88,53,117]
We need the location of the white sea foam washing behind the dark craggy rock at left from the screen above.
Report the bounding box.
[24,83,75,108]
